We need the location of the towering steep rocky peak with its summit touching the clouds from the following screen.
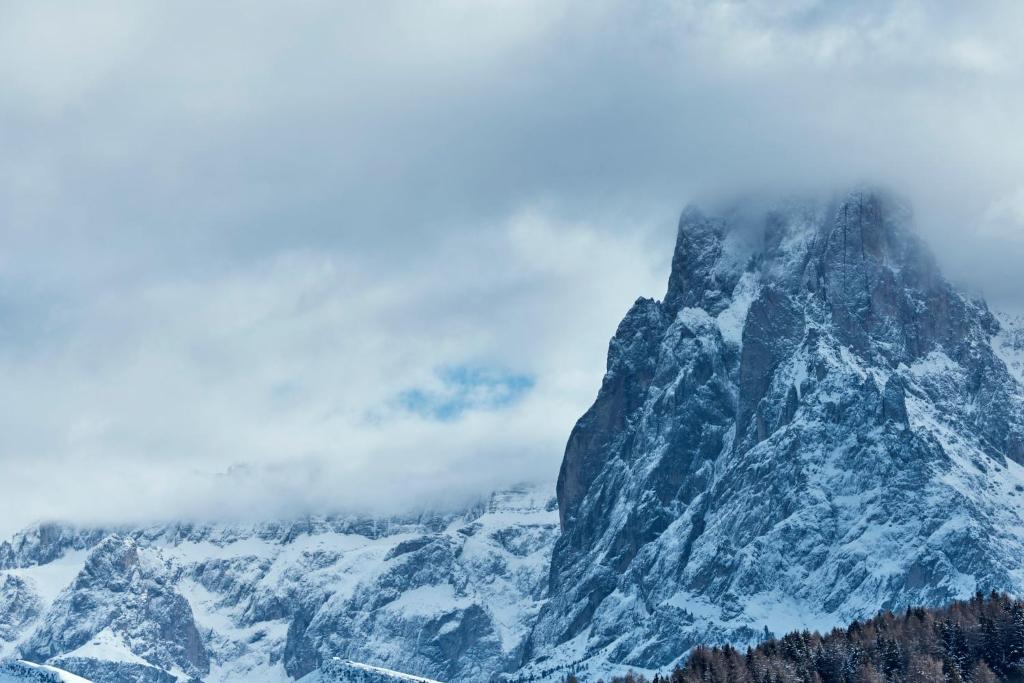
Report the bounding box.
[527,191,1024,671]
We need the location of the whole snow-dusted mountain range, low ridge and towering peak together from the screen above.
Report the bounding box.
[0,190,1024,683]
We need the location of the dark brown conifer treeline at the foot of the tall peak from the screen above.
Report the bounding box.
[589,593,1024,683]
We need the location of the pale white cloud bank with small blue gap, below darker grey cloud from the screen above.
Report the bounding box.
[0,212,662,523]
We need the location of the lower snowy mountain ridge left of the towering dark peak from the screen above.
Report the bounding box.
[0,486,558,683]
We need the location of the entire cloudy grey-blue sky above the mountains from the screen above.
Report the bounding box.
[0,0,1024,536]
